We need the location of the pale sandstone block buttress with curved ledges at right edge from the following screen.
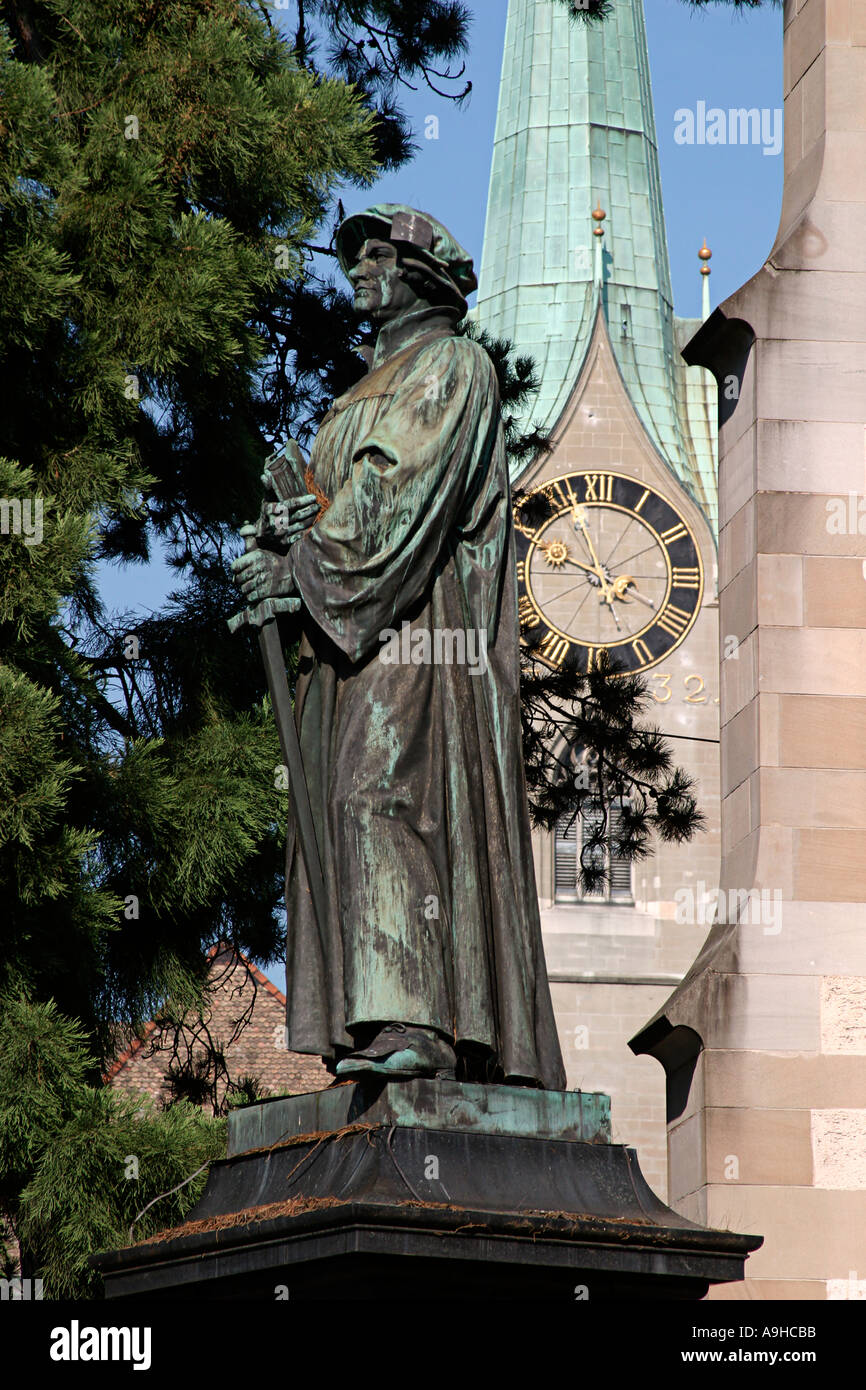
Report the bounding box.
[632,0,866,1295]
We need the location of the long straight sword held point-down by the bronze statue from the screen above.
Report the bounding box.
[228,441,328,938]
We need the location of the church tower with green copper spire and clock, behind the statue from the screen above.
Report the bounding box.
[477,0,720,1195]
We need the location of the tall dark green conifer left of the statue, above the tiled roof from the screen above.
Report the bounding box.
[0,0,377,1051]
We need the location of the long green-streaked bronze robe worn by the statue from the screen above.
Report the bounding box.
[286,309,564,1090]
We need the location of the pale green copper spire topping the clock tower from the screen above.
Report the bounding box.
[477,0,716,524]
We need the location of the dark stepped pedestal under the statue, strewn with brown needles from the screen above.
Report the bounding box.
[95,1080,762,1302]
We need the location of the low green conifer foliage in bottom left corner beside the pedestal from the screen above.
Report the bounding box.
[0,995,225,1298]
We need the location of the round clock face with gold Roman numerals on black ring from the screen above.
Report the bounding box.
[514,473,703,671]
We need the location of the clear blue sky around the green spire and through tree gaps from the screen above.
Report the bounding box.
[91,0,783,987]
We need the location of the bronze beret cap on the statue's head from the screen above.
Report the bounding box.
[335,203,478,313]
